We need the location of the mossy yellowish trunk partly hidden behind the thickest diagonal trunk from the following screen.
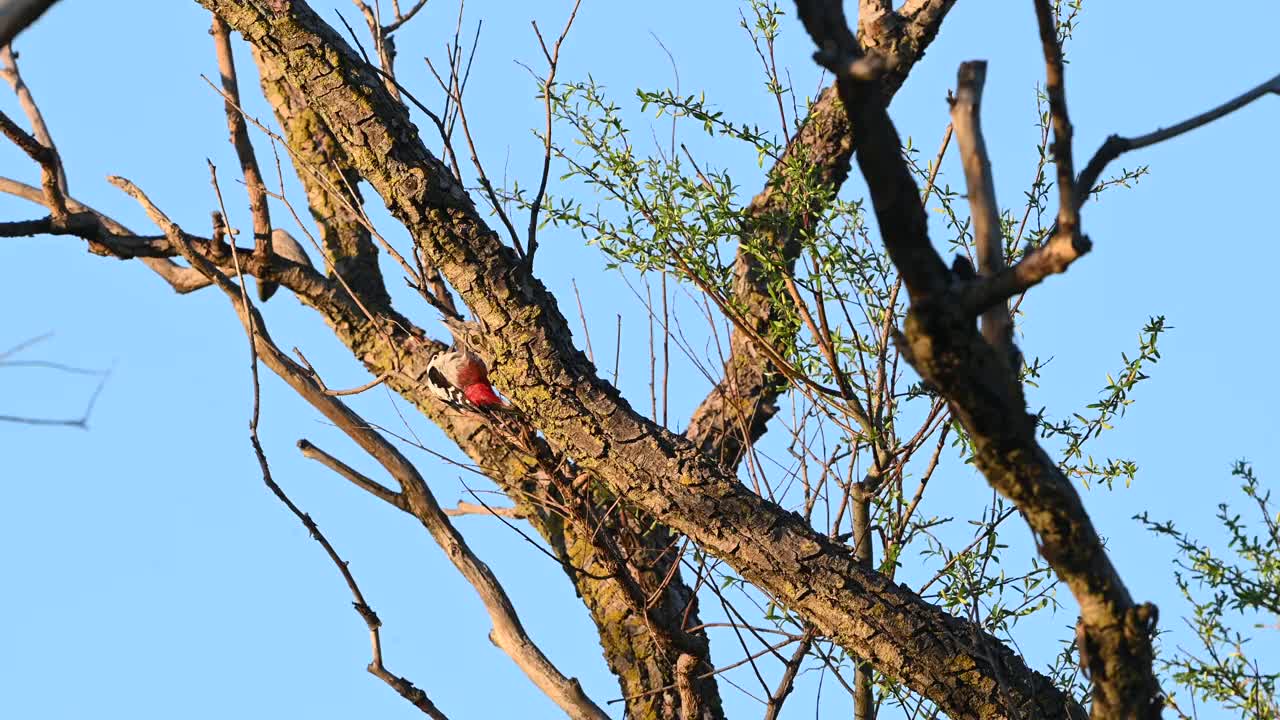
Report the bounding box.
[253,23,722,719]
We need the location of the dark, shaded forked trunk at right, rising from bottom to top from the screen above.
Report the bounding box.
[797,0,1161,717]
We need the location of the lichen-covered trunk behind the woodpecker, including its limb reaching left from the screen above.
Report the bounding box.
[10,26,722,707]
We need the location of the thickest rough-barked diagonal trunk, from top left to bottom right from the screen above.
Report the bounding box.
[200,0,1079,717]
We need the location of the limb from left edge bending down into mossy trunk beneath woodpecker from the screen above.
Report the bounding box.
[0,169,722,719]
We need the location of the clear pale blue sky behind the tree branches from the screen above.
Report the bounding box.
[0,0,1280,719]
